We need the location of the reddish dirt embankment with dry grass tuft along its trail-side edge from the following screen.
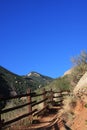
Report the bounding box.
[60,100,87,130]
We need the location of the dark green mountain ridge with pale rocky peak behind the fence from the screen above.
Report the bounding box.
[0,66,53,96]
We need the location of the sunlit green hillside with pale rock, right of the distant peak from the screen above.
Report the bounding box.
[46,66,87,91]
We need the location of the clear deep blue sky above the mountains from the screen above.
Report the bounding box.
[0,0,87,78]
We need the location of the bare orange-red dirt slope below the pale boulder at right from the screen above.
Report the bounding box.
[60,101,87,130]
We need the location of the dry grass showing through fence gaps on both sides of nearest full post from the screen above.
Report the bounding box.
[1,89,43,130]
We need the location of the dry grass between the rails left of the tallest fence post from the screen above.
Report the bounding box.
[1,100,30,130]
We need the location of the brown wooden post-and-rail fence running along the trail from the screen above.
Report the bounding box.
[0,89,67,130]
